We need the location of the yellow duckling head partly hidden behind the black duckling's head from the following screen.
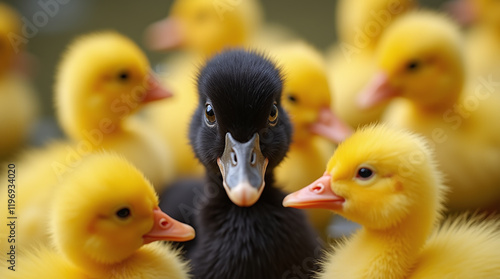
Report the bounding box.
[276,42,351,145]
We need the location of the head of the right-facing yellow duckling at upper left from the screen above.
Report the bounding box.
[55,32,171,139]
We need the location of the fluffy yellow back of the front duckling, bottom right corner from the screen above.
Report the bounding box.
[409,214,500,278]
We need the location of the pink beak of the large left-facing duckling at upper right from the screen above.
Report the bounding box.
[358,72,401,109]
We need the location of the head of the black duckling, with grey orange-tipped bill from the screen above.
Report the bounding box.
[189,50,292,207]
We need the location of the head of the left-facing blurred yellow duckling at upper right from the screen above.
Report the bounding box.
[358,12,464,110]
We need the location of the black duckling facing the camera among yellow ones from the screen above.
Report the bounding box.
[183,50,322,279]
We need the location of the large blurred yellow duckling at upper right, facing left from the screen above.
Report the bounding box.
[359,12,500,210]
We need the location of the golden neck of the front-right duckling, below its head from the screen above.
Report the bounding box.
[338,209,434,279]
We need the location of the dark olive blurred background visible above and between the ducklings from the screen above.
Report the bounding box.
[4,0,445,118]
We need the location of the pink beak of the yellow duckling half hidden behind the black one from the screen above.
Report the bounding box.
[309,108,353,143]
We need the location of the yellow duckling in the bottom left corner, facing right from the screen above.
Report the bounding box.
[0,153,195,279]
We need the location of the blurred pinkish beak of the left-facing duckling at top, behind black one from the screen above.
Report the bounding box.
[146,17,185,51]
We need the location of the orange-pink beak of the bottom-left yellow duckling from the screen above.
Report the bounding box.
[142,207,195,244]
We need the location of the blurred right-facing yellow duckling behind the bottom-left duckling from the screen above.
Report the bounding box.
[0,32,173,254]
